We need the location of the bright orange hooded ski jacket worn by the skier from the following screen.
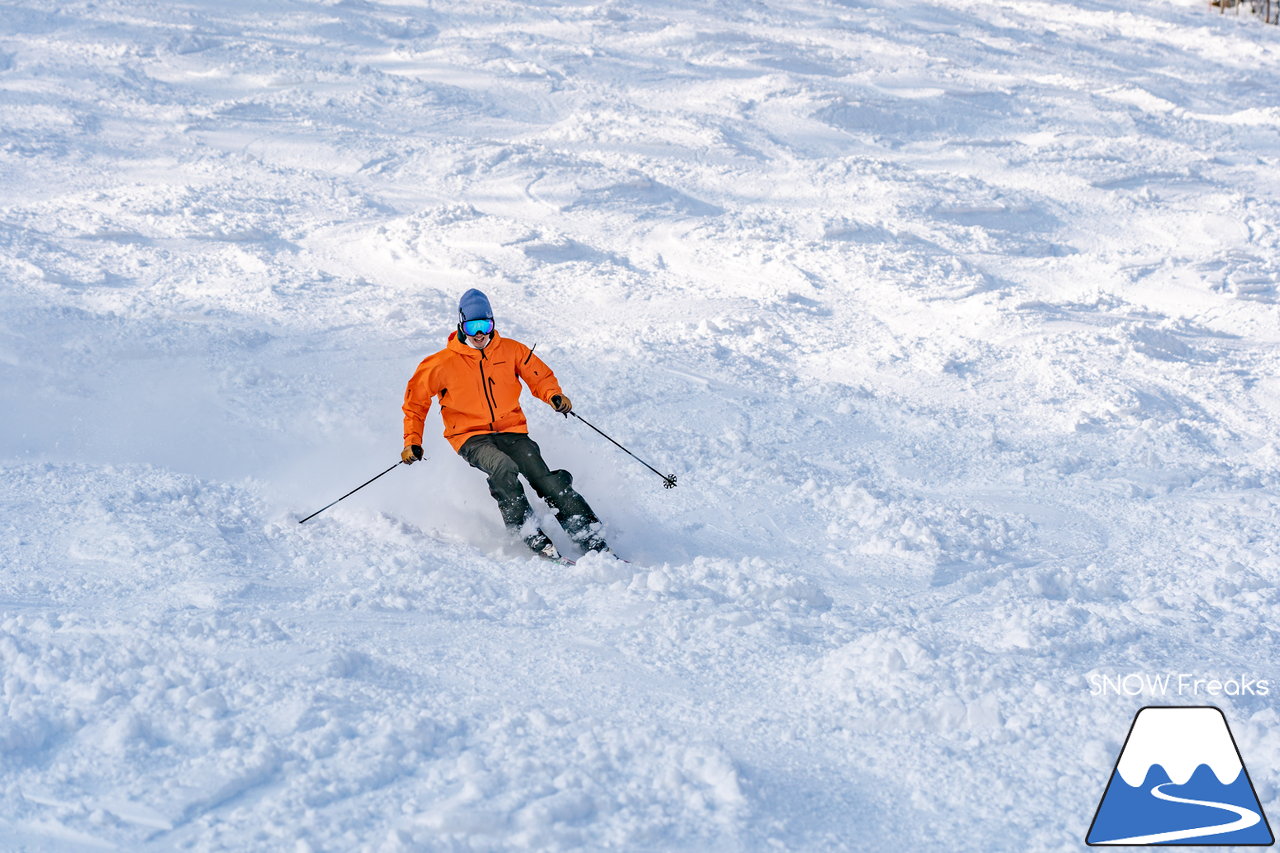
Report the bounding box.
[404,332,562,451]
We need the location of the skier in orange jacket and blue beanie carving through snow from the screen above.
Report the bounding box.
[401,288,609,558]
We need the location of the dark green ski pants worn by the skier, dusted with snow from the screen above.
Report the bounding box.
[458,433,599,543]
